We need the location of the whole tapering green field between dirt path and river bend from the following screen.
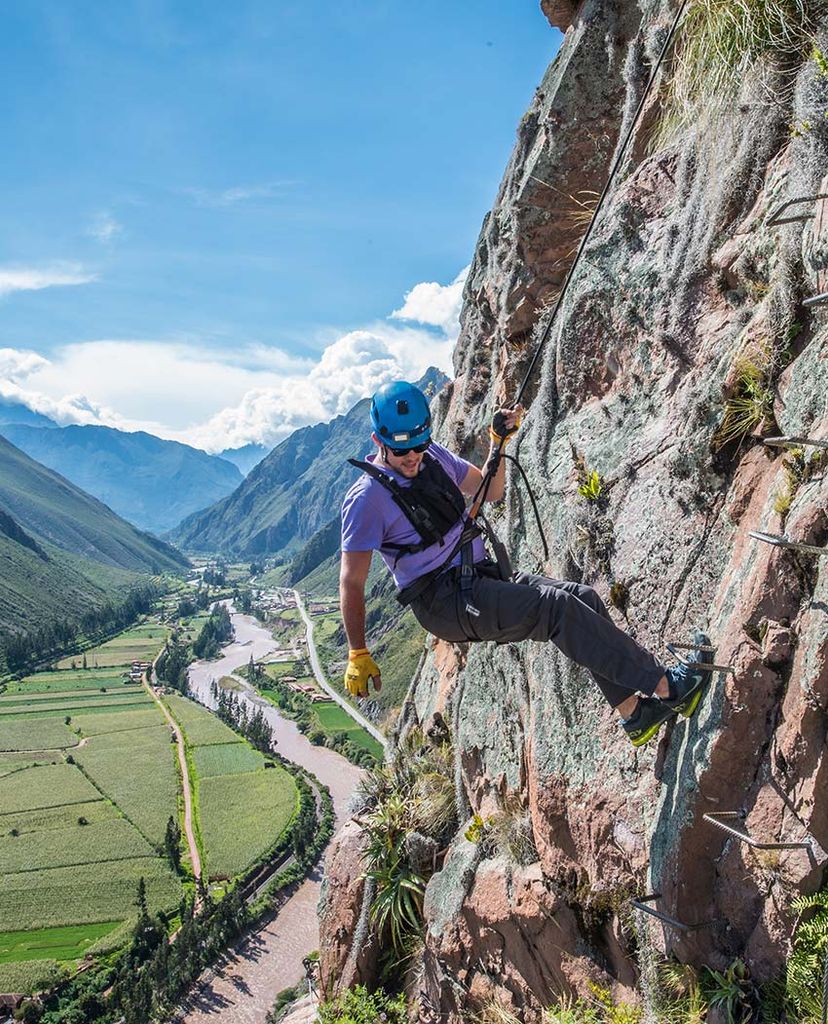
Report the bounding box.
[165,694,299,880]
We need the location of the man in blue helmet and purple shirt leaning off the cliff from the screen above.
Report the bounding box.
[340,381,710,746]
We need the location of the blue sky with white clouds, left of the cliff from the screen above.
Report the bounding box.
[0,0,561,447]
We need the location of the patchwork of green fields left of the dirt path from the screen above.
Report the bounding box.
[0,626,183,992]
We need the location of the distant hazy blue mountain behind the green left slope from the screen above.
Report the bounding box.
[0,424,244,534]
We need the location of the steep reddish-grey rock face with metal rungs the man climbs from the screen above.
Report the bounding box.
[322,0,828,1021]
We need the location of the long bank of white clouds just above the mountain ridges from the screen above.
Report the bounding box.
[0,271,466,452]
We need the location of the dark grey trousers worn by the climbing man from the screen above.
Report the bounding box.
[411,562,664,708]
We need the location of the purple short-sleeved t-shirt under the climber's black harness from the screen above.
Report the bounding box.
[342,441,486,588]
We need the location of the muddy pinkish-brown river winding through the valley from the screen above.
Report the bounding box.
[178,612,361,1024]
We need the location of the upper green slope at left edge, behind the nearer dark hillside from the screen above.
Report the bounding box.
[0,437,187,587]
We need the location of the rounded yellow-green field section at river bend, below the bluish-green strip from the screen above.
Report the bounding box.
[199,767,299,879]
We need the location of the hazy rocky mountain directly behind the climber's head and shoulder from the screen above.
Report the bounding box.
[169,369,446,558]
